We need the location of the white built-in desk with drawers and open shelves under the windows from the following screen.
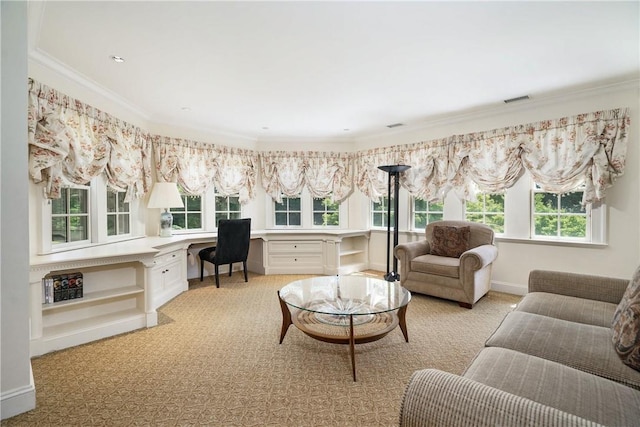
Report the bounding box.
[29,230,369,356]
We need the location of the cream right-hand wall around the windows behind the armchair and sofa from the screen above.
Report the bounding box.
[357,77,640,291]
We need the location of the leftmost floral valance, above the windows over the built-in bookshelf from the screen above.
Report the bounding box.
[28,79,151,201]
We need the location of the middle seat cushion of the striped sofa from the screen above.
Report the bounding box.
[486,311,640,389]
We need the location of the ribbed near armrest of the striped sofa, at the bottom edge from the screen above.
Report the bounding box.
[400,369,597,427]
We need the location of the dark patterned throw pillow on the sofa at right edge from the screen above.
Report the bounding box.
[612,267,640,370]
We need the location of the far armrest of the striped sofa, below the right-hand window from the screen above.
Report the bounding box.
[529,270,629,304]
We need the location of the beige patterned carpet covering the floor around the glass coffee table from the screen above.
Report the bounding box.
[2,272,520,426]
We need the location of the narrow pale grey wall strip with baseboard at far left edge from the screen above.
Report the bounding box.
[0,1,36,419]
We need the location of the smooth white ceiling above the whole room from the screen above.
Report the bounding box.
[29,1,640,141]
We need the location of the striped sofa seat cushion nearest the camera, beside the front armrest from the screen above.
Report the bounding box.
[463,347,640,426]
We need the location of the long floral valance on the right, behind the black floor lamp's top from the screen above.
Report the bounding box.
[356,109,630,203]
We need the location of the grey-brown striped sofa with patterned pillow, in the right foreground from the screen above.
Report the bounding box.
[400,268,640,427]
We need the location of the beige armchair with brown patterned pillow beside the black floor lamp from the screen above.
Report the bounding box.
[393,221,498,308]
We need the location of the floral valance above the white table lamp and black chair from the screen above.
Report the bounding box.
[153,136,257,204]
